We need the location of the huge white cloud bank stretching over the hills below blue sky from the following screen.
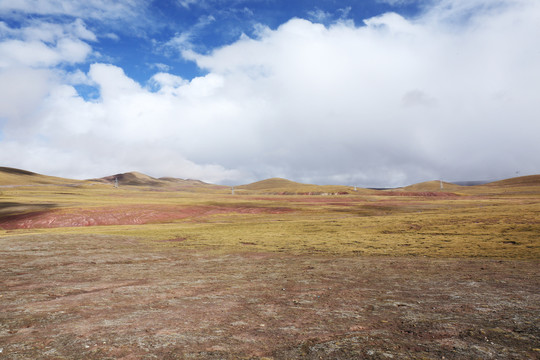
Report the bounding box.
[0,0,540,186]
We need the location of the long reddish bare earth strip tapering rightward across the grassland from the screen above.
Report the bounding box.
[0,205,291,230]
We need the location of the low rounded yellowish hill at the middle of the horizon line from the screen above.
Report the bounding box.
[236,178,371,195]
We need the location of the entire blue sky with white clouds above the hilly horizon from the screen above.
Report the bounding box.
[0,0,540,187]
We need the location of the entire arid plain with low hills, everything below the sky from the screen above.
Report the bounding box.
[0,168,540,359]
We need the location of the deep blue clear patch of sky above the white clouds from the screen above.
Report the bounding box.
[56,0,422,88]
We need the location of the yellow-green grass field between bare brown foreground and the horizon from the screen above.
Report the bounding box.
[0,170,540,259]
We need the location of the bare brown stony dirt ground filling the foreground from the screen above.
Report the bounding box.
[0,234,540,359]
